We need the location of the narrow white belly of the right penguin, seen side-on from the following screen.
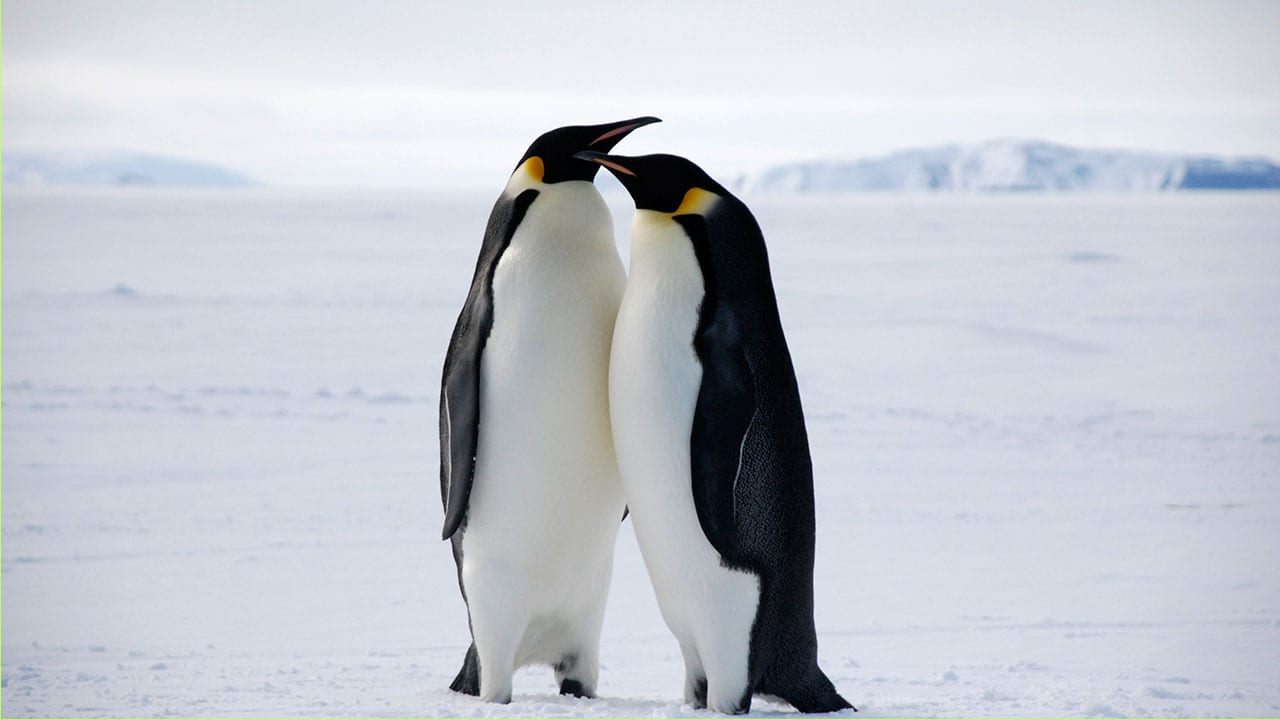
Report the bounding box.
[609,211,759,655]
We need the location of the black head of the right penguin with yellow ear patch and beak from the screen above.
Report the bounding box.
[575,150,730,215]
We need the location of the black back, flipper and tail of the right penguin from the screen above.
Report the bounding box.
[675,192,851,712]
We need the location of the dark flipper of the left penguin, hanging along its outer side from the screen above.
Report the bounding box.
[440,190,538,539]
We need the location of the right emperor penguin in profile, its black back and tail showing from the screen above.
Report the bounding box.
[577,152,852,714]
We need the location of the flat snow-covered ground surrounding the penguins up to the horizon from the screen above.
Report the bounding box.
[3,188,1280,717]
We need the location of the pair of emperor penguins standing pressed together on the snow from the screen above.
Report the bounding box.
[440,117,851,714]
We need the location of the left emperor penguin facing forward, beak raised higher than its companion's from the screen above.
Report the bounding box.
[440,117,659,703]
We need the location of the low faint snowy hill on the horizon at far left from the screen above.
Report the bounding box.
[4,151,253,187]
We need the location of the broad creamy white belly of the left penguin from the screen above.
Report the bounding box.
[462,182,625,664]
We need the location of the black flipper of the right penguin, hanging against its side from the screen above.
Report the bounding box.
[690,335,755,562]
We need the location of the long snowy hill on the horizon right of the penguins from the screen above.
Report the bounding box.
[739,140,1280,193]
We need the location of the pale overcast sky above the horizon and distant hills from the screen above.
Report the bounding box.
[3,0,1280,187]
